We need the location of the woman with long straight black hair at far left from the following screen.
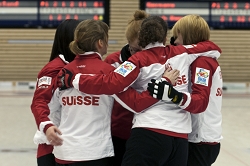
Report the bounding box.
[31,19,80,166]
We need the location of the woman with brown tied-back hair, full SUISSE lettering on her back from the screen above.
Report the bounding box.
[46,20,162,166]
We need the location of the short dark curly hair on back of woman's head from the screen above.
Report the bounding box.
[138,16,168,48]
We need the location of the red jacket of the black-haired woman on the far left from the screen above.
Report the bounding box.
[31,55,68,157]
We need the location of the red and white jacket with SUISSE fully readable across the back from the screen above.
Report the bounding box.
[50,52,158,162]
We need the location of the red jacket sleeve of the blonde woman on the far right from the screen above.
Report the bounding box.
[181,57,217,113]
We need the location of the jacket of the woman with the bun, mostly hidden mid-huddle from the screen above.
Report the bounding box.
[104,51,134,140]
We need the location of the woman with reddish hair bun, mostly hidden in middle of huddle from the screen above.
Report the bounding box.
[104,10,148,166]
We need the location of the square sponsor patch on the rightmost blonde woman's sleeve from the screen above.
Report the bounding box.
[194,67,210,86]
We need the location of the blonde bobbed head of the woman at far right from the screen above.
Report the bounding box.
[172,15,210,45]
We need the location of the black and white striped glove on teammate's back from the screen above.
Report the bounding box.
[147,79,183,104]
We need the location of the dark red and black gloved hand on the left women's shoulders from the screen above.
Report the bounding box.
[57,68,74,90]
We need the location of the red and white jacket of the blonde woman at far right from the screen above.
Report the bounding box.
[188,57,223,143]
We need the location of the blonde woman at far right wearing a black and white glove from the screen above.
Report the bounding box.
[146,15,223,166]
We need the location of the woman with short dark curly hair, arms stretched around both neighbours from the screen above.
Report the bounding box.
[58,16,220,166]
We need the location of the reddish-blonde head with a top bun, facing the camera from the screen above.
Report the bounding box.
[125,10,149,42]
